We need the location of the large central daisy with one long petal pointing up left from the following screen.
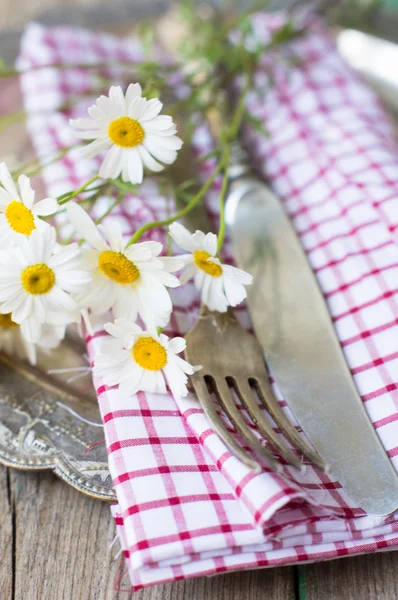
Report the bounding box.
[67,203,184,328]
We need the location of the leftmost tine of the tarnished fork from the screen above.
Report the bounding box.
[191,375,261,473]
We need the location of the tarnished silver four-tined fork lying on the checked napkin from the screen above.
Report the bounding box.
[171,135,325,472]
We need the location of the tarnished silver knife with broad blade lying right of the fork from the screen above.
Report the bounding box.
[226,147,398,515]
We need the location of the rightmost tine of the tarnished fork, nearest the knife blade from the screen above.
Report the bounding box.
[254,378,327,471]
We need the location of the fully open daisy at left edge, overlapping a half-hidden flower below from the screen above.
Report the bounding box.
[0,226,90,343]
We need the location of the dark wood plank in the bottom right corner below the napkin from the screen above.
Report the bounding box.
[299,552,398,600]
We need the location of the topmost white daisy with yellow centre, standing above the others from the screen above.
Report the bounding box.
[70,83,182,183]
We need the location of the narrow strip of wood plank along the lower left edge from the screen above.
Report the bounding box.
[0,466,14,600]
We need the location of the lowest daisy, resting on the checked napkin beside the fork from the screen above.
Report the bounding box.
[94,319,197,400]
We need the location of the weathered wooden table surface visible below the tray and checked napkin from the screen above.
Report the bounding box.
[0,467,398,600]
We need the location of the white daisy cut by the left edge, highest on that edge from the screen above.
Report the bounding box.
[0,163,58,248]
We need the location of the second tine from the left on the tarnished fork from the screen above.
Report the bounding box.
[214,377,282,472]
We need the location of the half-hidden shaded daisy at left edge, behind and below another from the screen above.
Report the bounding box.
[0,313,65,365]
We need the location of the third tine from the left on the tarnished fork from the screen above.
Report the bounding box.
[236,379,303,469]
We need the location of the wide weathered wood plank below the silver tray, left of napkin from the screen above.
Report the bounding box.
[9,471,131,600]
